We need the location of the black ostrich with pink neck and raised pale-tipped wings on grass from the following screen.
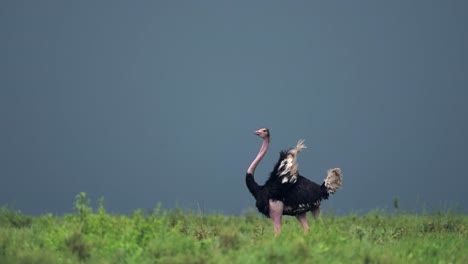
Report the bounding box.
[245,128,342,235]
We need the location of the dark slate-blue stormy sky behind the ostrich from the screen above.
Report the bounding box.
[0,0,468,214]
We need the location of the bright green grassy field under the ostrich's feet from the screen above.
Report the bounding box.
[0,193,468,264]
